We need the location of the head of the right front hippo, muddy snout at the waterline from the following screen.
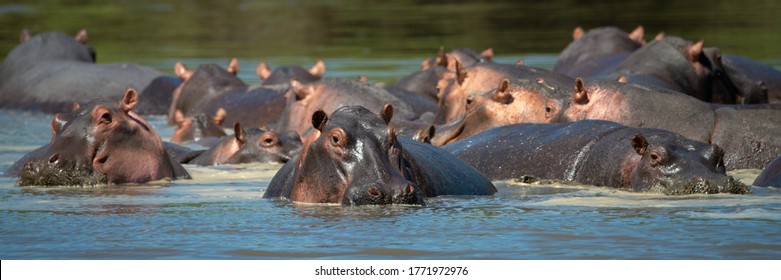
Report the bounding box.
[624,133,750,195]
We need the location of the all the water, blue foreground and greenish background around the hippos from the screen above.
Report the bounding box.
[0,1,781,259]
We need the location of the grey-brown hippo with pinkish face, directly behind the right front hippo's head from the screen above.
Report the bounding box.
[559,78,781,170]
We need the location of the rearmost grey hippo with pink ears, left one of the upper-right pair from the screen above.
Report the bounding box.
[553,26,646,78]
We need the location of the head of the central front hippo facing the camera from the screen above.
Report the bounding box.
[290,104,423,205]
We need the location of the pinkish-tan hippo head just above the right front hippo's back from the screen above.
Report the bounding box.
[431,78,562,146]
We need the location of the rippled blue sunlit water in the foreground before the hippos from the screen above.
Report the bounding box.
[0,99,781,259]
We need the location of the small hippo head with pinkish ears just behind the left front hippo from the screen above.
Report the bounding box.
[171,108,227,143]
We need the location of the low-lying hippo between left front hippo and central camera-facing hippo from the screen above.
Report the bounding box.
[175,123,301,165]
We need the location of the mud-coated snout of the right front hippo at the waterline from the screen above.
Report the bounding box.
[665,176,751,195]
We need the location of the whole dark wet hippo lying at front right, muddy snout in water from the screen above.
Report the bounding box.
[442,120,751,195]
